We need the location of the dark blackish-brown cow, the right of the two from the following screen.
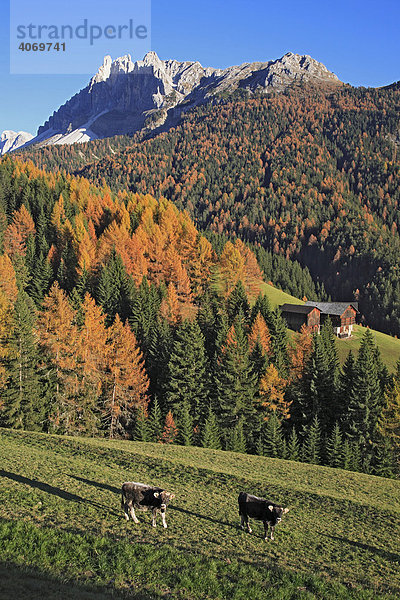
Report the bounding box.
[238,492,289,540]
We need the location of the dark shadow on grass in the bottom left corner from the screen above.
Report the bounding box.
[0,562,156,600]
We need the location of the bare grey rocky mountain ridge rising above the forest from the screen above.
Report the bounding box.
[21,51,342,151]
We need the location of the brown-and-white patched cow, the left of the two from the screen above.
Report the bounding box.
[121,481,175,529]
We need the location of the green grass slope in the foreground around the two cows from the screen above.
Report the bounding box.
[0,430,400,600]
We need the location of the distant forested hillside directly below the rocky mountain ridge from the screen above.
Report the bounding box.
[19,85,400,335]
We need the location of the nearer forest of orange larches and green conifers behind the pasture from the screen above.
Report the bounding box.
[0,158,400,476]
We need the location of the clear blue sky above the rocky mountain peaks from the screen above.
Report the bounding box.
[0,0,400,133]
